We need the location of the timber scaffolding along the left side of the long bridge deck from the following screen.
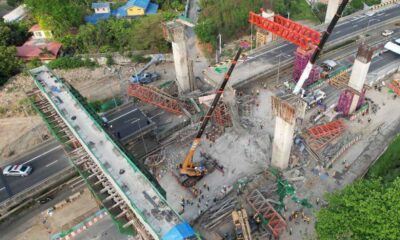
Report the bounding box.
[28,88,143,236]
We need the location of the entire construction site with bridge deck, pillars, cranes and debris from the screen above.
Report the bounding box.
[18,0,400,240]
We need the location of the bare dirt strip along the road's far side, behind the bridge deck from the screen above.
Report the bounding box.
[0,62,175,164]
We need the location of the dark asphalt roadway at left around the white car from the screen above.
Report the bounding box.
[0,142,70,202]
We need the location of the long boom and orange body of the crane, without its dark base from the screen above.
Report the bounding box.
[180,47,242,177]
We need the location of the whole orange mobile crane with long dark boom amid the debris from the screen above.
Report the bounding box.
[179,45,244,187]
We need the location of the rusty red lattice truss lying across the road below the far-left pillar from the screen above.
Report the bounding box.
[128,83,183,114]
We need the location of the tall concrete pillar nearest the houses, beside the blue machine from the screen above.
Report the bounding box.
[164,21,194,94]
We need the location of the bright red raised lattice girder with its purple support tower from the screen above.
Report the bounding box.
[249,12,321,87]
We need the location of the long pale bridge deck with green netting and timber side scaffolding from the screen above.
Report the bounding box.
[29,66,196,240]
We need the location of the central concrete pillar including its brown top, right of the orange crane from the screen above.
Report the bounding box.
[271,97,306,169]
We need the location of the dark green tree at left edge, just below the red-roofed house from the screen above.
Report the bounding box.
[0,46,22,86]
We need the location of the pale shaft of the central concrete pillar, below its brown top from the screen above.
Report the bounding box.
[271,116,295,169]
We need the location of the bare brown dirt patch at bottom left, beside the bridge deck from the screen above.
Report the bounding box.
[15,189,99,240]
